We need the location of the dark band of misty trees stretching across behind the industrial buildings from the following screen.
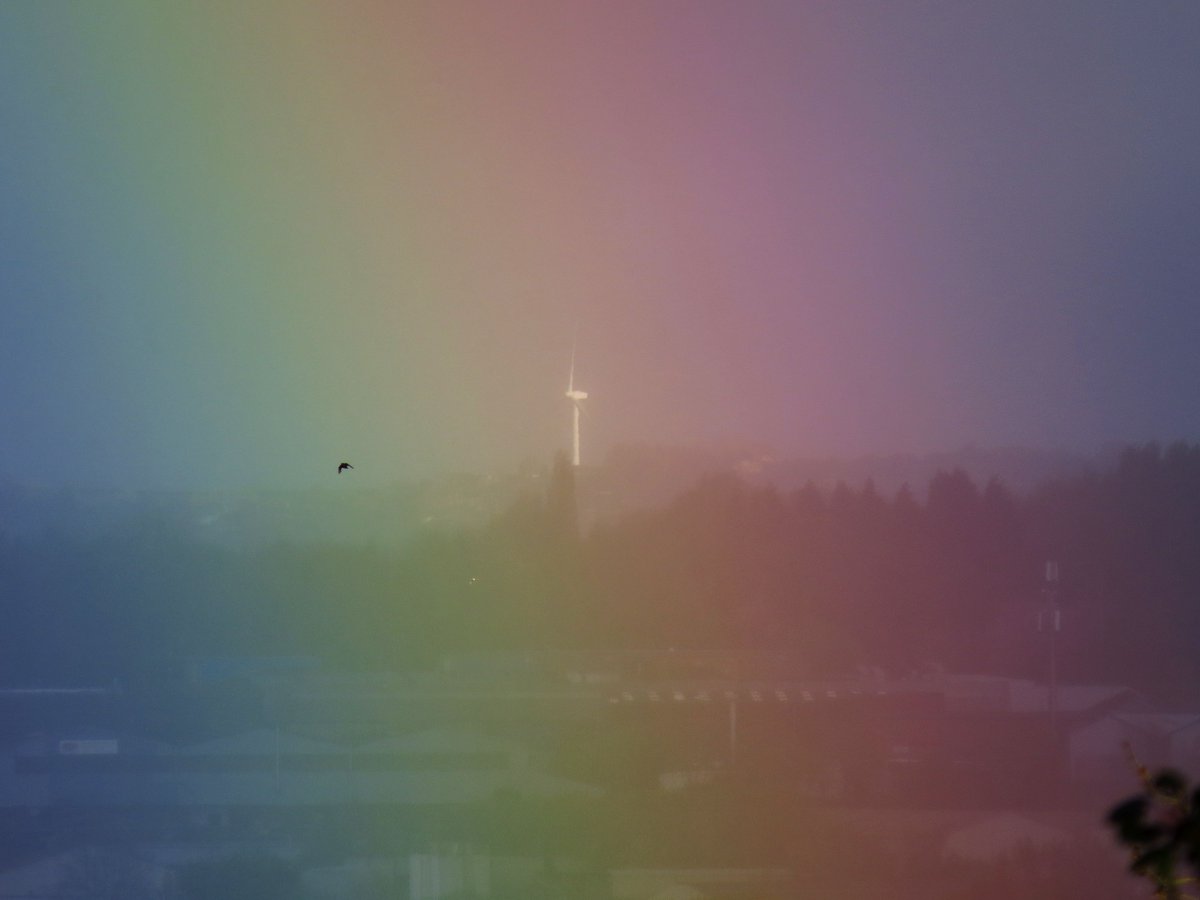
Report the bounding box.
[0,443,1200,701]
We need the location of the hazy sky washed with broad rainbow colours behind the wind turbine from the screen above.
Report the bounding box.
[0,0,1200,487]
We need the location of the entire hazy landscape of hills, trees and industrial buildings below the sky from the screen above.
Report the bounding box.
[0,445,1185,900]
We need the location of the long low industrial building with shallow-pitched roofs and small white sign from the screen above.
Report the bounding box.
[0,728,594,812]
